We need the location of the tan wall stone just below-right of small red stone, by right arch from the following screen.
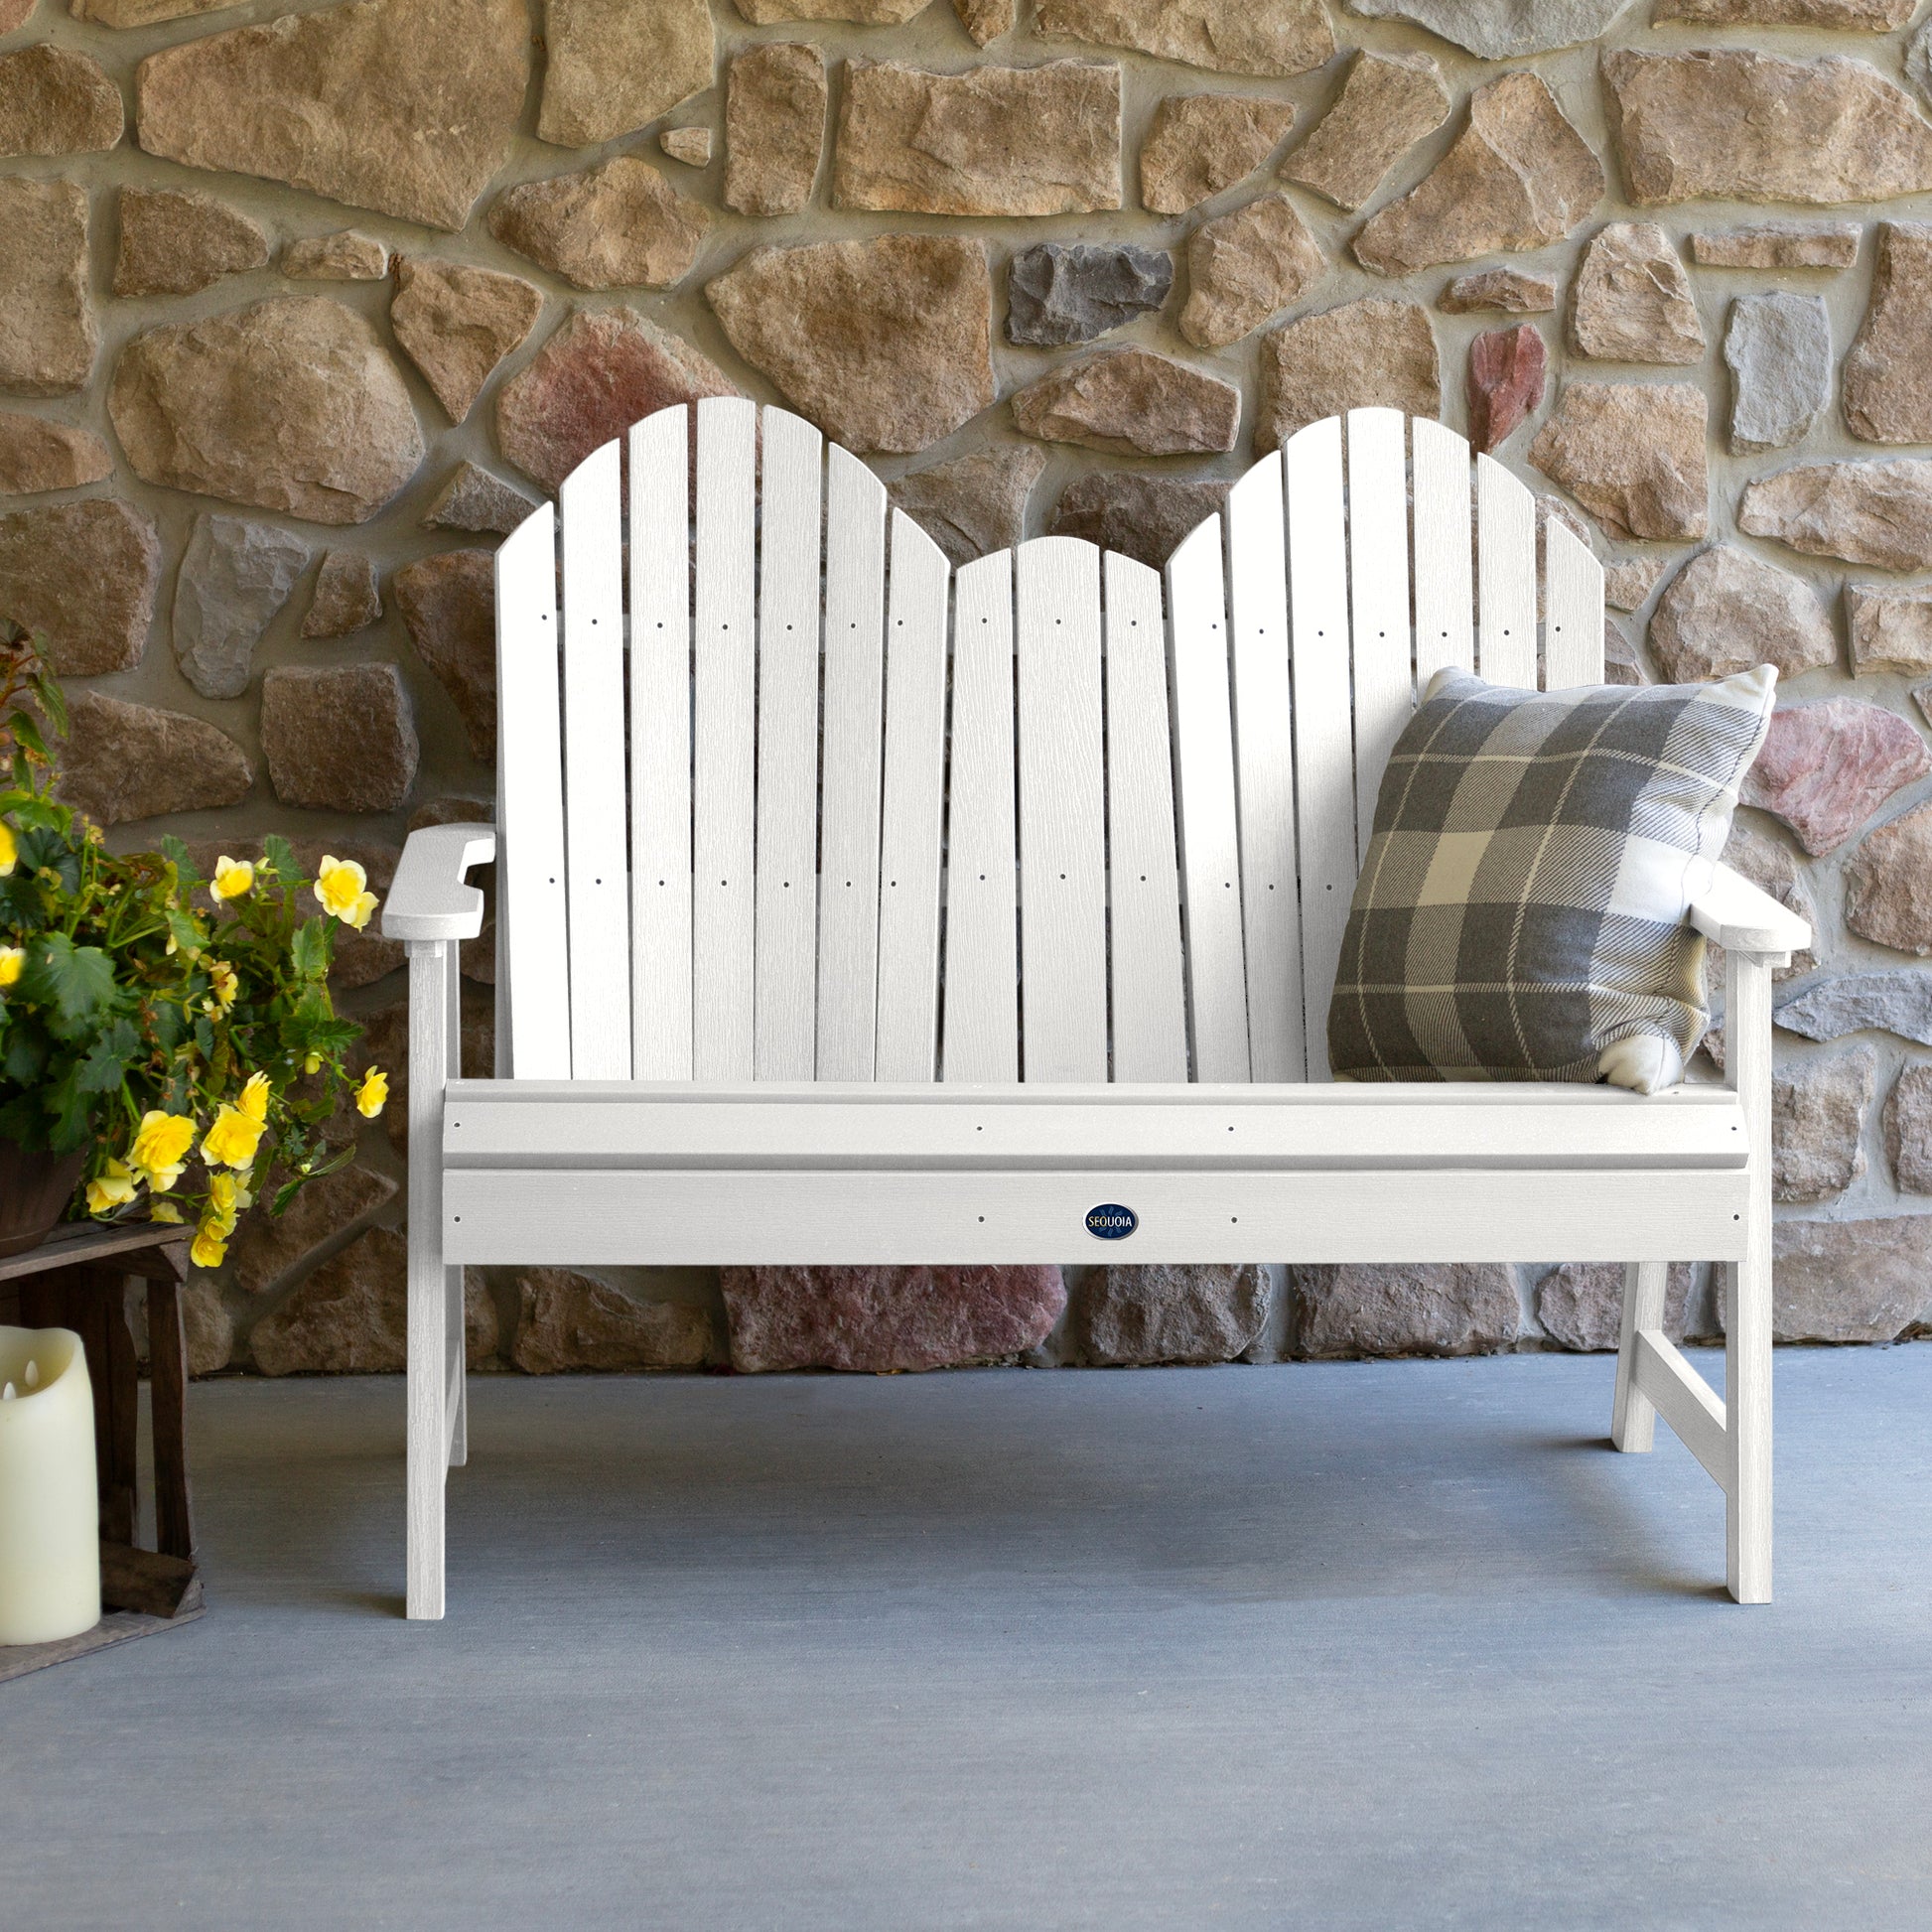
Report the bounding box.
[1530,382,1710,539]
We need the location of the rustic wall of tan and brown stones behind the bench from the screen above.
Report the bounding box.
[0,0,1932,1374]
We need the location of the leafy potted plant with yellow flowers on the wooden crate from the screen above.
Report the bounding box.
[0,626,388,1268]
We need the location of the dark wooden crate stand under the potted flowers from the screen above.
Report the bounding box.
[0,1221,203,1683]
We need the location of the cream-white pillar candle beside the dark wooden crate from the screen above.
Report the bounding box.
[0,1327,100,1644]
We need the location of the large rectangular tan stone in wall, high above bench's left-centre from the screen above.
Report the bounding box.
[833,60,1121,214]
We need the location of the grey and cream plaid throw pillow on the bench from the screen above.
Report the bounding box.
[1329,664,1777,1093]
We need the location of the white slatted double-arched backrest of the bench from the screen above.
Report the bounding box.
[496,398,1603,1082]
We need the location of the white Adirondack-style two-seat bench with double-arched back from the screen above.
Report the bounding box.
[382,400,1808,1617]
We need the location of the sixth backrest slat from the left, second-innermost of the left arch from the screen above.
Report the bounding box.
[817,445,885,1080]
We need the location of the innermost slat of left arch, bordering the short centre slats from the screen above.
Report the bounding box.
[874,510,952,1080]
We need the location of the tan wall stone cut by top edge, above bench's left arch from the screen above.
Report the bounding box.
[537,0,715,147]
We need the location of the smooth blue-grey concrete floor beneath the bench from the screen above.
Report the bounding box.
[0,1346,1932,1932]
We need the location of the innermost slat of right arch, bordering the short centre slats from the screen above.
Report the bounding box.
[1167,518,1248,1080]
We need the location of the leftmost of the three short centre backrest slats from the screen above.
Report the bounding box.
[943,551,1020,1084]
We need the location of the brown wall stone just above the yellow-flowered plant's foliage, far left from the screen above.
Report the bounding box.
[60,692,255,825]
